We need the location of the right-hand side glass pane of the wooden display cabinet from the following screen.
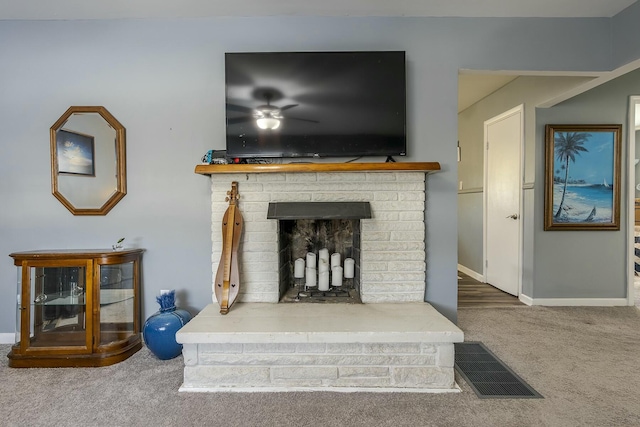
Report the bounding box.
[99,261,136,346]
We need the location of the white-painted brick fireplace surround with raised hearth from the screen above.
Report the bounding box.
[177,165,463,392]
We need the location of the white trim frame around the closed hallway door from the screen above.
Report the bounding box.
[482,104,524,298]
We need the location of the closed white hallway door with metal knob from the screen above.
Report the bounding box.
[484,106,523,296]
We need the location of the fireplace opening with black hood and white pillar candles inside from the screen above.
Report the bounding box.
[267,202,371,303]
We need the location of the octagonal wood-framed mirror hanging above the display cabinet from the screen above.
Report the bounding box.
[50,106,127,215]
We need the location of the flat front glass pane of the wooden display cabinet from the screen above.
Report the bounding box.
[22,265,91,351]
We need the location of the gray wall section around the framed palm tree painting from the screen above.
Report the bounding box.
[531,70,640,298]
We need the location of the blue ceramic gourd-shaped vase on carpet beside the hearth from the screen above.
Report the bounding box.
[142,290,191,360]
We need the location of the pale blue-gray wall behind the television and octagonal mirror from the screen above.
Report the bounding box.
[0,17,632,333]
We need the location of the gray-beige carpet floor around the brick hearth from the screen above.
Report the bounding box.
[0,307,640,427]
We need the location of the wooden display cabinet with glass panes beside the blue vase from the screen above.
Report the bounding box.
[7,249,144,368]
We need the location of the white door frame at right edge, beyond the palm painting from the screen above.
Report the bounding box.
[627,95,640,305]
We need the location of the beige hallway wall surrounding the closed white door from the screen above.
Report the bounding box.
[458,76,590,286]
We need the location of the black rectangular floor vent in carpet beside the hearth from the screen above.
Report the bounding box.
[455,342,543,399]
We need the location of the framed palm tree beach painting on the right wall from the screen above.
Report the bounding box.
[544,125,622,230]
